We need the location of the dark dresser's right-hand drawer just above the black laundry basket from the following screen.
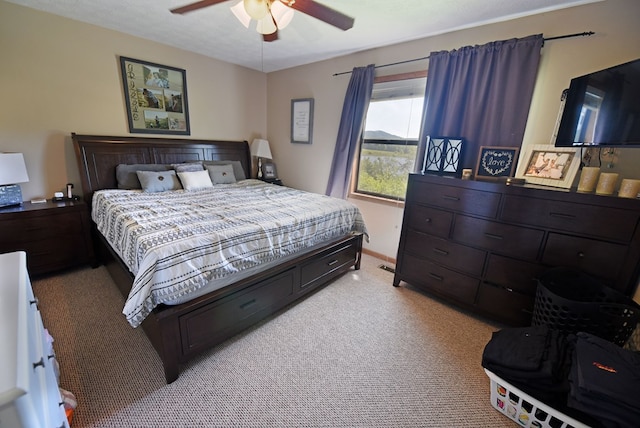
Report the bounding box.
[542,233,627,279]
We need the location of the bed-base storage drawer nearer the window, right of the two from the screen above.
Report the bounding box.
[300,240,358,289]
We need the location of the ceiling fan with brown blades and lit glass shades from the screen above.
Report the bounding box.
[171,0,354,42]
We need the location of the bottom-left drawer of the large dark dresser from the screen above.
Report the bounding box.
[402,254,478,304]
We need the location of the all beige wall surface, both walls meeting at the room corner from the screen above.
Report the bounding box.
[0,0,640,294]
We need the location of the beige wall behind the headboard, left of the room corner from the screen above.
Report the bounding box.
[0,1,267,199]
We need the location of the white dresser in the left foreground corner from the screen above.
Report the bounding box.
[0,251,69,428]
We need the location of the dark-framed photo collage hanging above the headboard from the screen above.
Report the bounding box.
[120,57,191,135]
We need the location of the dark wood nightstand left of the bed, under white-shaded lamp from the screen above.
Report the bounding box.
[0,201,96,275]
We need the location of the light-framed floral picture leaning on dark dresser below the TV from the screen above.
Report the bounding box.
[523,144,580,189]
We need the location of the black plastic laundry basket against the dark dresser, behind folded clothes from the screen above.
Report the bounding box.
[532,268,640,346]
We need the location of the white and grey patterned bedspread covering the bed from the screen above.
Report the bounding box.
[92,180,367,327]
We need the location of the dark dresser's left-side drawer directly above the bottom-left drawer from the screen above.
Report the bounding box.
[405,232,486,276]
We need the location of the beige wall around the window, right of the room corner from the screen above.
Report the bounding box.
[267,0,640,258]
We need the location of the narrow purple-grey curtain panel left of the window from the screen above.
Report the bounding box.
[326,64,375,199]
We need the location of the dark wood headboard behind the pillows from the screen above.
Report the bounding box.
[71,133,251,205]
